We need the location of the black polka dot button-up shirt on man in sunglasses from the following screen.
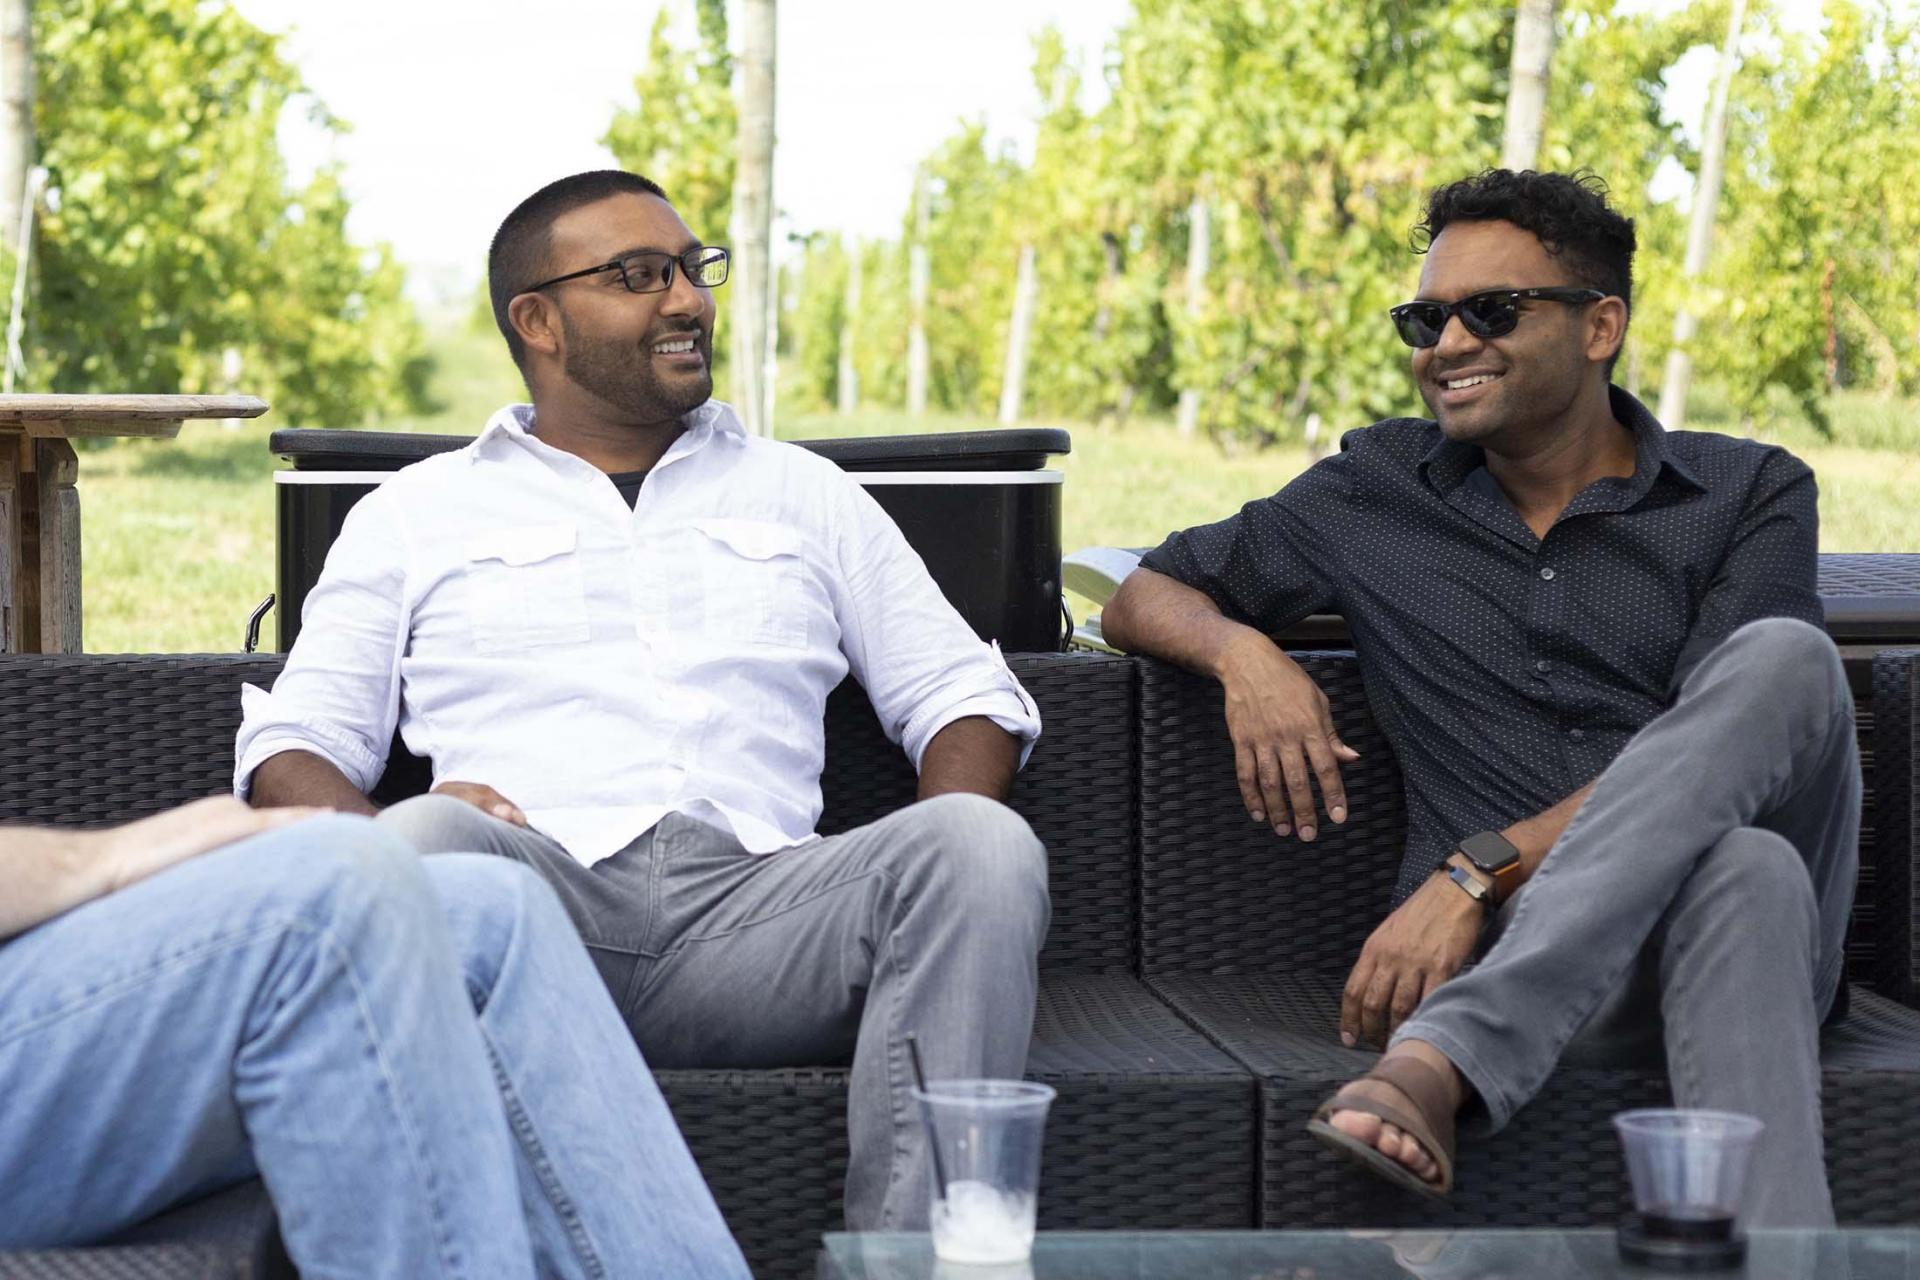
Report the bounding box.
[1142,390,1822,902]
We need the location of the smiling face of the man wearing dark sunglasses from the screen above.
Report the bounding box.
[1413,221,1624,447]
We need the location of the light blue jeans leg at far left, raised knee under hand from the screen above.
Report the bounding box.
[0,818,534,1280]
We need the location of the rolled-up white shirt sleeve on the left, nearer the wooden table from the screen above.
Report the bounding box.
[234,491,409,796]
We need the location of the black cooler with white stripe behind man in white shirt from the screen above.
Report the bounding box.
[269,428,1071,652]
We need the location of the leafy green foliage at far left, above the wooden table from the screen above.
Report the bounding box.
[27,0,432,426]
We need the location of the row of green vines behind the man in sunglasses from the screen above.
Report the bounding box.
[781,0,1920,450]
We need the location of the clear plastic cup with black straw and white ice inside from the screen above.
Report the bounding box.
[914,1080,1054,1265]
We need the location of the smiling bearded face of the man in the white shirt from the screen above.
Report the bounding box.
[545,194,714,422]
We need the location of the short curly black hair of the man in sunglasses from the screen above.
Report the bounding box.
[1413,169,1636,376]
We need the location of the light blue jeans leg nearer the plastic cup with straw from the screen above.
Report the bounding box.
[424,854,747,1280]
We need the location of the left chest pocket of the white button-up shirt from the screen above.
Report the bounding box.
[467,524,588,652]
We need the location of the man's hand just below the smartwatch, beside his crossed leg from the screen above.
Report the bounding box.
[1340,873,1484,1048]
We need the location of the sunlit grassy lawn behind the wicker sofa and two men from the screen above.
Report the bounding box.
[81,334,1920,652]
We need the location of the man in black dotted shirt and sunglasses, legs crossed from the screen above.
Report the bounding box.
[1104,171,1860,1226]
